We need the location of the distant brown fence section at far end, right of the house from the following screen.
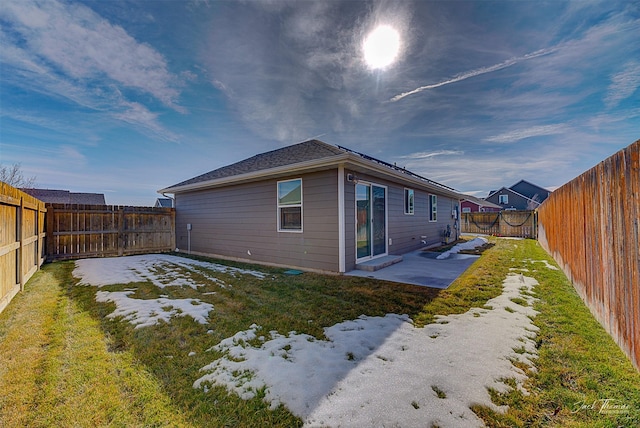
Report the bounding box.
[461,211,538,239]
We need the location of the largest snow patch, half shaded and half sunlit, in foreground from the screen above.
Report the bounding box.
[194,274,537,427]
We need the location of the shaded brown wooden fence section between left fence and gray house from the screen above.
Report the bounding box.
[47,204,175,260]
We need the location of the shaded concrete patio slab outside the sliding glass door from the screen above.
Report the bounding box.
[345,250,480,289]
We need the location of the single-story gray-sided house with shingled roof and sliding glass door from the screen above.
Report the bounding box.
[158,140,464,273]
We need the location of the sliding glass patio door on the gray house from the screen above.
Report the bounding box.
[356,183,387,259]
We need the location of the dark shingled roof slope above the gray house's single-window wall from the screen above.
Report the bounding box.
[171,140,346,187]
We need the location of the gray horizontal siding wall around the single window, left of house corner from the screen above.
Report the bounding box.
[176,170,339,272]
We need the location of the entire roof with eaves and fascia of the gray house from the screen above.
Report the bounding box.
[158,140,464,199]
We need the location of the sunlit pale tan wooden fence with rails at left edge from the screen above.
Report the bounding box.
[0,182,46,312]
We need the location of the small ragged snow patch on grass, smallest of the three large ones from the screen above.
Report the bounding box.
[96,290,213,328]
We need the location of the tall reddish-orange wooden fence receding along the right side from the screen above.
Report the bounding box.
[538,140,640,370]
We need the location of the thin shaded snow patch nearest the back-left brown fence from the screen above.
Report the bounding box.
[73,254,266,289]
